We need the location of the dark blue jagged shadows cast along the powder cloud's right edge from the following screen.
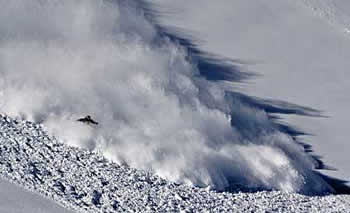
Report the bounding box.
[140,2,350,194]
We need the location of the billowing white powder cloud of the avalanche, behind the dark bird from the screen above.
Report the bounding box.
[0,0,333,193]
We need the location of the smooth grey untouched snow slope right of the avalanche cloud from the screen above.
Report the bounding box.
[153,0,350,183]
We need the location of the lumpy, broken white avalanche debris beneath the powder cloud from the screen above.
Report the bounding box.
[0,115,350,213]
